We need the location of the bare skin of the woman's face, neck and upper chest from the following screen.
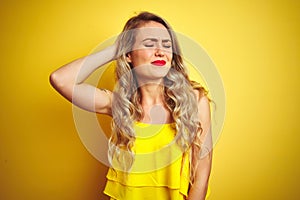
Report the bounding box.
[127,21,172,123]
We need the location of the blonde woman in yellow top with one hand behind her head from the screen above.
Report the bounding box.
[50,12,212,200]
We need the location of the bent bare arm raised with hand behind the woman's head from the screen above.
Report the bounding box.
[50,45,116,115]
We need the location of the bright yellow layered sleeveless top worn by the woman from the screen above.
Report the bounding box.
[104,122,209,200]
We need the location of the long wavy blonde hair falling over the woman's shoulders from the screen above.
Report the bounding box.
[108,12,206,183]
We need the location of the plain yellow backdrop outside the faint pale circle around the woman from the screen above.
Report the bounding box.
[0,0,300,200]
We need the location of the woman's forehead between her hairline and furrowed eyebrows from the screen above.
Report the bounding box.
[136,21,171,41]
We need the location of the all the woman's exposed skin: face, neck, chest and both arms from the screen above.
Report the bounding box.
[50,21,212,200]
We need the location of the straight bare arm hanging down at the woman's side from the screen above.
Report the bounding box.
[188,96,212,200]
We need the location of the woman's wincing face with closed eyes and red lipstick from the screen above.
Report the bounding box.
[127,21,172,83]
